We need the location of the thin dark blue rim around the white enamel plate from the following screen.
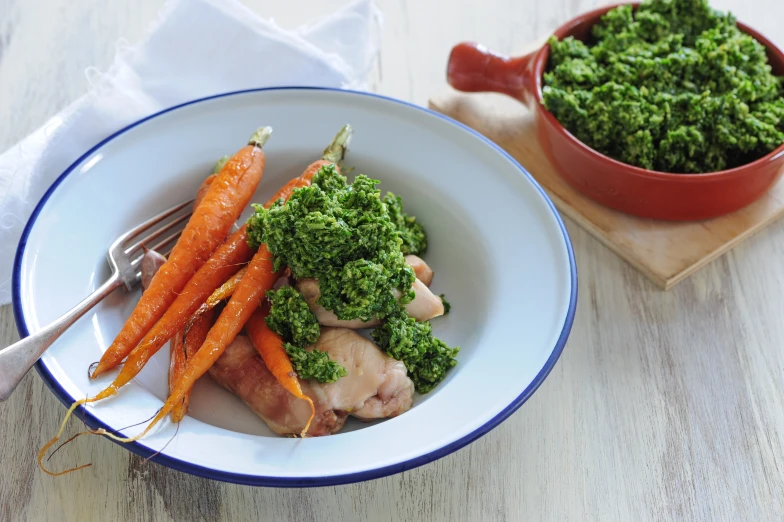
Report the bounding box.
[12,86,577,487]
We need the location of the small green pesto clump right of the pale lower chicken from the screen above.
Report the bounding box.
[371,311,460,393]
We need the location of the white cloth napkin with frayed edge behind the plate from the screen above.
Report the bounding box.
[0,0,381,304]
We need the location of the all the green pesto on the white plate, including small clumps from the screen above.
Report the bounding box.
[247,165,459,393]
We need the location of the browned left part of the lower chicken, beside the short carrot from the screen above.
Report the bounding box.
[209,335,348,436]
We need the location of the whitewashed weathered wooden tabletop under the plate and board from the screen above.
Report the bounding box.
[0,0,784,521]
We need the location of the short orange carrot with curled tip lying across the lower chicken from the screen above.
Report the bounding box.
[245,301,316,437]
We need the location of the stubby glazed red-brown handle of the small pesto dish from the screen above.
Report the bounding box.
[446,42,539,105]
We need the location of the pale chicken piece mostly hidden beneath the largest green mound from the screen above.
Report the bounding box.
[296,279,444,330]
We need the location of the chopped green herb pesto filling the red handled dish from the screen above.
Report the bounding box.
[542,0,784,173]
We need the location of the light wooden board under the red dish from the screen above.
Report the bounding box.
[429,88,784,290]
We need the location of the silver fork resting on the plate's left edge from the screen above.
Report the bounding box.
[0,200,193,401]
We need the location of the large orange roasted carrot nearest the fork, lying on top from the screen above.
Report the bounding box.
[91,127,272,378]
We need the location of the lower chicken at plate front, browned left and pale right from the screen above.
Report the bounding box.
[210,328,414,436]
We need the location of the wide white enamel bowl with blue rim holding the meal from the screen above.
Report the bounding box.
[13,88,577,486]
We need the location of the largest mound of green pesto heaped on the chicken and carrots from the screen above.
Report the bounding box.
[247,165,415,321]
